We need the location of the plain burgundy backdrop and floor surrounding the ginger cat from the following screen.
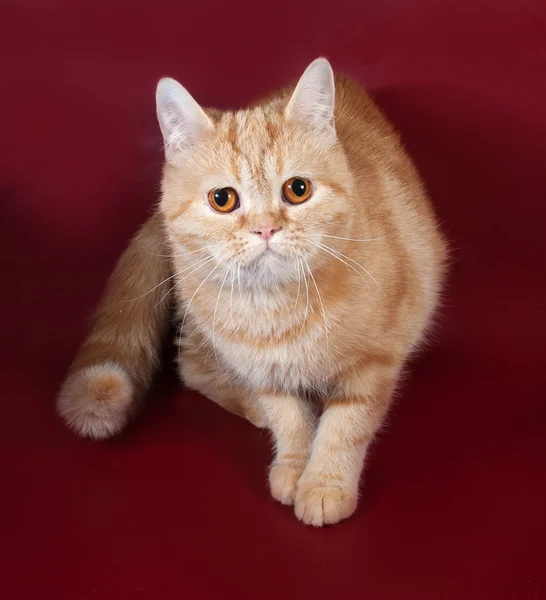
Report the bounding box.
[0,0,546,600]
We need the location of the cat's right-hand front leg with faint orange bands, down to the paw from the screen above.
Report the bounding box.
[295,360,398,526]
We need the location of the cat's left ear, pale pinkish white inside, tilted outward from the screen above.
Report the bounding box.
[156,77,214,161]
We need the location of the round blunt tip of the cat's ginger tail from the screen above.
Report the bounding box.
[57,362,135,439]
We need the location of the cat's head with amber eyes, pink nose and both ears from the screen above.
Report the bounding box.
[157,59,354,286]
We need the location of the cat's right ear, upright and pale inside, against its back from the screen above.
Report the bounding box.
[286,58,336,135]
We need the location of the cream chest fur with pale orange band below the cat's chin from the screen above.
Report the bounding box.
[178,280,337,393]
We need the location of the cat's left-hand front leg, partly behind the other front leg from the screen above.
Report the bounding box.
[259,395,315,504]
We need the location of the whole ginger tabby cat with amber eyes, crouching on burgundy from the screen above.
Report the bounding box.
[57,58,447,526]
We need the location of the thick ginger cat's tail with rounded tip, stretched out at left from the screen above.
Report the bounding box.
[57,213,171,439]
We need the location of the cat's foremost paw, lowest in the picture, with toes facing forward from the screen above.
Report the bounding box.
[295,481,358,527]
